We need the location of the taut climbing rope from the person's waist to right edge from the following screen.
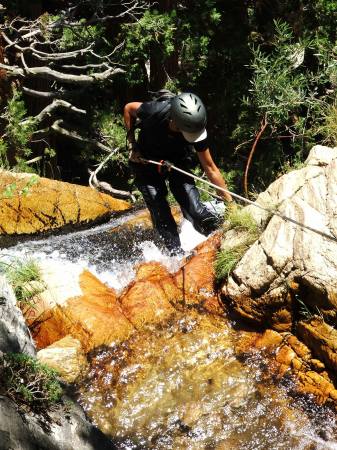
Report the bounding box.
[140,158,337,243]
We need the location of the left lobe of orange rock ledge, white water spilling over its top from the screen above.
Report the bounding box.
[30,269,133,351]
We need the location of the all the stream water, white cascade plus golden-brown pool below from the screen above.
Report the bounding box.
[1,209,337,450]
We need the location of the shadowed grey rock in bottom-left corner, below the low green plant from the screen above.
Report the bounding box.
[0,397,116,450]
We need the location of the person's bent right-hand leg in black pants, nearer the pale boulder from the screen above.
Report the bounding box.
[169,172,220,235]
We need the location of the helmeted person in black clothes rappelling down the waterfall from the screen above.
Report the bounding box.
[124,91,232,254]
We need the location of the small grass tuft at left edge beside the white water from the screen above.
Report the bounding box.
[0,258,44,306]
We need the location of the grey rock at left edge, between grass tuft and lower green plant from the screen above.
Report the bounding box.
[0,276,36,356]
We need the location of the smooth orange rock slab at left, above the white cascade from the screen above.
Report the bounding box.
[0,171,130,235]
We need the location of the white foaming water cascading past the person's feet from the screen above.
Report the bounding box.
[0,219,206,292]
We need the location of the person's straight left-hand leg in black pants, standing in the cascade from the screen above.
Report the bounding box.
[132,164,181,252]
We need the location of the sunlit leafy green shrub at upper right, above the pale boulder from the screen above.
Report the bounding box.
[234,21,308,139]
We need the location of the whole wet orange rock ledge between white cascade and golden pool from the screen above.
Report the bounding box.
[26,235,223,352]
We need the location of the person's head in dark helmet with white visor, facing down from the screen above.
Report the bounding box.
[170,92,207,142]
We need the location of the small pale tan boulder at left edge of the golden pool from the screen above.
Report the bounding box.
[37,336,87,383]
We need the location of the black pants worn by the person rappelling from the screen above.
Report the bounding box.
[131,163,219,252]
